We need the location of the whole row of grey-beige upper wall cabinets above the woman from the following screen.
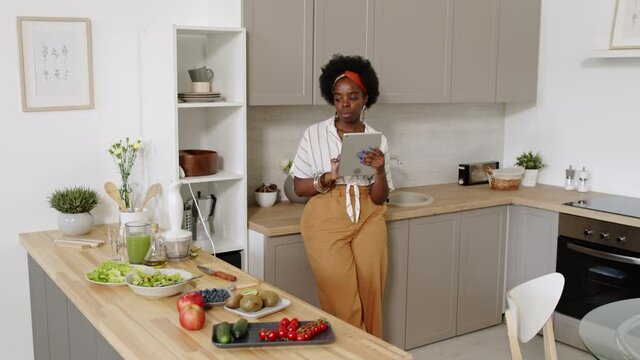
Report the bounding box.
[244,0,541,105]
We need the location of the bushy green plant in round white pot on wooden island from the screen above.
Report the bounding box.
[48,186,100,236]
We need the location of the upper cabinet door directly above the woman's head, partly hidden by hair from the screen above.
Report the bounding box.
[312,0,374,104]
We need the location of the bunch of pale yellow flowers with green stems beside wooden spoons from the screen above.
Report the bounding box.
[107,137,142,210]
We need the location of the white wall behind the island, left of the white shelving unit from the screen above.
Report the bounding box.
[0,0,240,359]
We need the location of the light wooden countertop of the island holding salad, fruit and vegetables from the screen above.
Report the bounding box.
[20,226,411,359]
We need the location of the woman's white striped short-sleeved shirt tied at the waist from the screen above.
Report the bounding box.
[289,117,393,222]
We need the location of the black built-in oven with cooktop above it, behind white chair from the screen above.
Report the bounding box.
[554,195,640,348]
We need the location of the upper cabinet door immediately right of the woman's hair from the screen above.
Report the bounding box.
[373,0,454,103]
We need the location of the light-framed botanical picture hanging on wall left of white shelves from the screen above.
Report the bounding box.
[18,17,94,111]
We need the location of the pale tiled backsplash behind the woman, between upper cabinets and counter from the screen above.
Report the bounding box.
[247,104,504,202]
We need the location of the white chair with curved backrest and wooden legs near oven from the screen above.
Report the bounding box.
[505,273,564,360]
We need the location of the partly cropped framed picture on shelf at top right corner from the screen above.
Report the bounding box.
[609,0,640,49]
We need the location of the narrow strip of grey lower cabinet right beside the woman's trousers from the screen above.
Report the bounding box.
[382,220,409,349]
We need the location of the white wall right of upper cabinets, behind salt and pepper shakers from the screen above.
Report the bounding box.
[504,0,640,197]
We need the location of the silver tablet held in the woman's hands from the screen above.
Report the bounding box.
[338,133,382,176]
